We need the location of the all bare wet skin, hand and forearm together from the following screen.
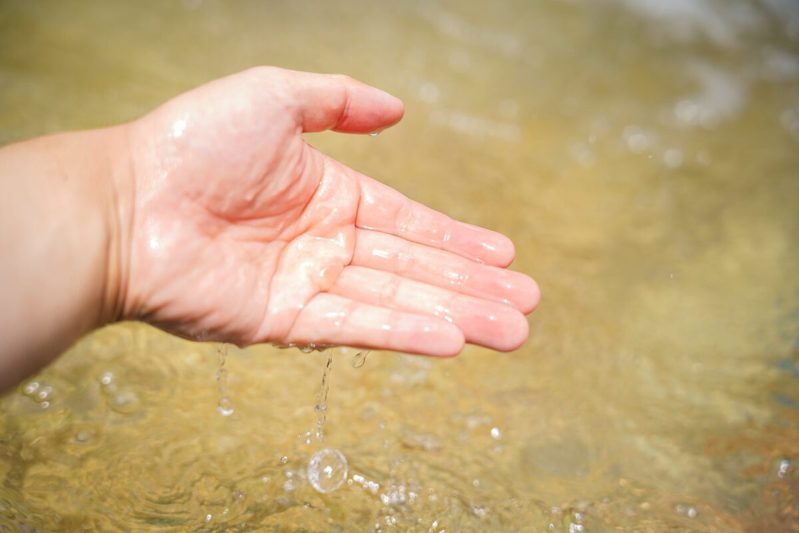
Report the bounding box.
[0,67,539,389]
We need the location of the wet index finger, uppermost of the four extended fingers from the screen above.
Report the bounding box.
[355,174,516,267]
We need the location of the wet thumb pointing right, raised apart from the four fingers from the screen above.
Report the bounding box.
[286,71,404,133]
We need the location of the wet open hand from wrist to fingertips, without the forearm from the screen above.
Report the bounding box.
[121,67,539,356]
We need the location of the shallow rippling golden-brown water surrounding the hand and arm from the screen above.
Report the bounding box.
[0,0,799,532]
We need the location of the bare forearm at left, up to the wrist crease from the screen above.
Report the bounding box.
[0,128,127,391]
